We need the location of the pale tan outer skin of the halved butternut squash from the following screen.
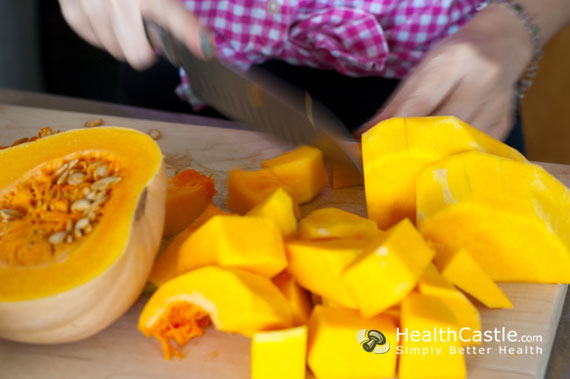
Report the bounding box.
[0,127,166,344]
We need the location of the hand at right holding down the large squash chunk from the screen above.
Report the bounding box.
[357,5,533,140]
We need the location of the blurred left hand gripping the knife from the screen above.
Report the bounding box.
[59,0,209,70]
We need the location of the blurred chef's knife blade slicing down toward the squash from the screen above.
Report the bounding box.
[145,21,362,172]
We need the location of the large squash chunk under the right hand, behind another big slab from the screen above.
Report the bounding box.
[362,117,525,229]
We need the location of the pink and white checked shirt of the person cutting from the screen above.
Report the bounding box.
[177,0,482,103]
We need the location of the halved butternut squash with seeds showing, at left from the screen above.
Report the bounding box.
[0,127,166,343]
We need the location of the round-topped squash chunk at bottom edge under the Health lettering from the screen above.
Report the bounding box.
[398,292,466,379]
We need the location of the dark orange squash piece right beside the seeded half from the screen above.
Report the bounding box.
[164,170,216,237]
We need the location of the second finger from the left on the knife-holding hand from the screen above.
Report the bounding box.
[79,0,125,60]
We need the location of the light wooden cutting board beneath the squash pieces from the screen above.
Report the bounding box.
[0,105,570,379]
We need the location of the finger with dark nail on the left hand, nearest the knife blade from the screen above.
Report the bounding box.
[141,0,211,59]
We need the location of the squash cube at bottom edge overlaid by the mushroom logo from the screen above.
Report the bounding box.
[307,305,398,379]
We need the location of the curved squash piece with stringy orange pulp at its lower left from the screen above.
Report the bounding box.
[138,266,292,359]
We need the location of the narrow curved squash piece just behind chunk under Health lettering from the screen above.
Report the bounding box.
[418,263,481,345]
